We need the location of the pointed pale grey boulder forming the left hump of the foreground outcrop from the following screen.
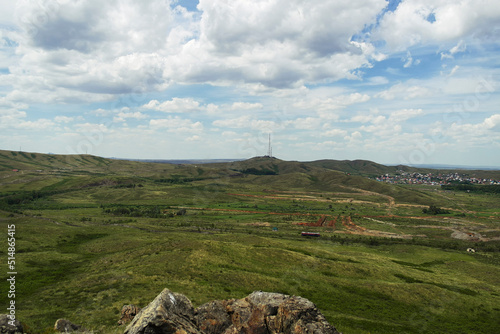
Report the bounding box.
[124,289,202,334]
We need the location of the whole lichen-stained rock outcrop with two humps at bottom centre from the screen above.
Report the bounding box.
[125,289,339,334]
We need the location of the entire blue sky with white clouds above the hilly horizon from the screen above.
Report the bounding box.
[0,0,500,168]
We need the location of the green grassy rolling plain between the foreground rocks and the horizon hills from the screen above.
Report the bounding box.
[0,151,500,334]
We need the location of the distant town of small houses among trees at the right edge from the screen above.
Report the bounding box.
[376,171,500,186]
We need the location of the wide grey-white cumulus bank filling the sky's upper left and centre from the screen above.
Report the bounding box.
[2,0,385,102]
